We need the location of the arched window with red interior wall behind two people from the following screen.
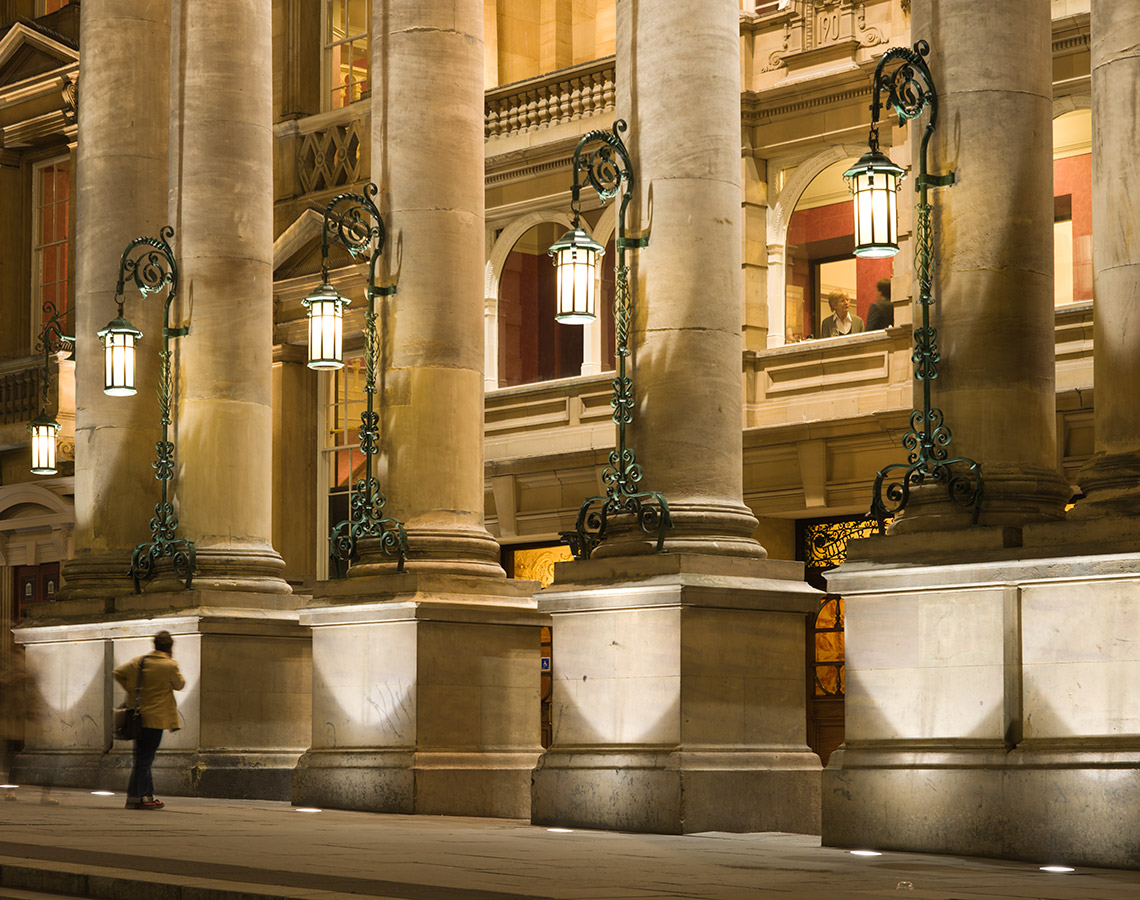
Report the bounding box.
[784,160,893,343]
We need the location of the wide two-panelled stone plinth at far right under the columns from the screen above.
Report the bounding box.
[823,524,1140,867]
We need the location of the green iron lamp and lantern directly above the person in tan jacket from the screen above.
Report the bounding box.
[99,225,195,593]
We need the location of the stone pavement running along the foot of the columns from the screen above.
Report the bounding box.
[0,787,1140,900]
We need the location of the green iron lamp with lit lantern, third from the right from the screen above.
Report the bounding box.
[301,184,408,571]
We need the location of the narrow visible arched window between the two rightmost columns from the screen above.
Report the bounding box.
[1053,110,1092,305]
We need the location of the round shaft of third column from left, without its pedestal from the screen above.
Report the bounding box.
[369,0,503,576]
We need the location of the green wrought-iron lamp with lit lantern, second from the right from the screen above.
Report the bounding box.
[549,119,673,559]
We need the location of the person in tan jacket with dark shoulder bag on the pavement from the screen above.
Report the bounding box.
[113,631,186,810]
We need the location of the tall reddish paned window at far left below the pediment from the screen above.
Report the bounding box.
[32,159,71,333]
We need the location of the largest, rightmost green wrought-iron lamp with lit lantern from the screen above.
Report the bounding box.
[844,41,984,534]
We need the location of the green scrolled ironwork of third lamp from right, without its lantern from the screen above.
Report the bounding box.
[320,183,408,571]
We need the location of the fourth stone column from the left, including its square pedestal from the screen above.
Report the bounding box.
[531,0,820,833]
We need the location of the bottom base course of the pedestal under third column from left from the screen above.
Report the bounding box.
[292,748,539,819]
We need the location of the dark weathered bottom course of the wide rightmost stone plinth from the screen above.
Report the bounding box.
[823,740,1140,869]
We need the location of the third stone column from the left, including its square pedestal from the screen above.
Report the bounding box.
[293,0,549,818]
